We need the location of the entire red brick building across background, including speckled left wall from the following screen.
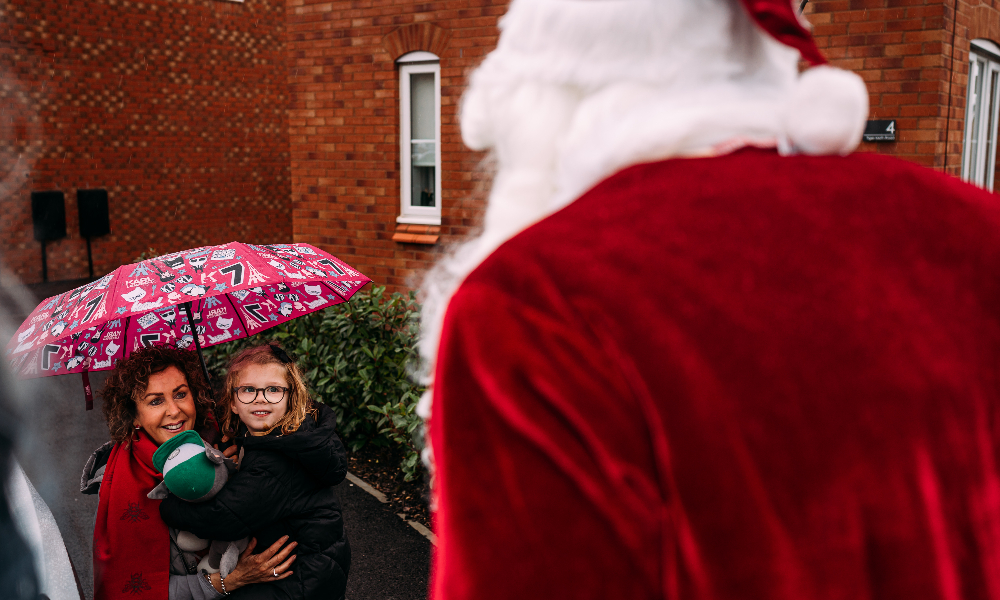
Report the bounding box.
[0,0,1000,289]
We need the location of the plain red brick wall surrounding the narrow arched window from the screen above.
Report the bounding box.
[288,0,507,290]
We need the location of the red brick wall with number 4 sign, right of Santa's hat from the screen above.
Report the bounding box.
[805,0,1000,185]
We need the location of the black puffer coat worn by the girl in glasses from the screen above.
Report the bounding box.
[160,404,351,600]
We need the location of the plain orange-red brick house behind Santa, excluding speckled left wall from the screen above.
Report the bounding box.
[289,0,1000,286]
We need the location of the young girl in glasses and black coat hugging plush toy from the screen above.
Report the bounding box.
[160,344,351,600]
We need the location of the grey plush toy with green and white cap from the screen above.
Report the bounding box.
[147,431,249,577]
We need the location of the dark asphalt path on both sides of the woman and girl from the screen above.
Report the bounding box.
[7,284,430,600]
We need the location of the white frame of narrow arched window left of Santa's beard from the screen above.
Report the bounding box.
[396,51,442,225]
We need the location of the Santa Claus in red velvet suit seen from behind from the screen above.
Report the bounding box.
[421,0,1000,600]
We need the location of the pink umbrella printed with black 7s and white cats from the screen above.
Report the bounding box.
[7,242,371,410]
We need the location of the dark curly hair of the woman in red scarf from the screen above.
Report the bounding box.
[100,346,215,444]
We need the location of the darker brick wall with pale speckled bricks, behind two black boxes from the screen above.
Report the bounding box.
[0,0,292,283]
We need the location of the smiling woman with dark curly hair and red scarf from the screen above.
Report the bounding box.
[81,346,295,600]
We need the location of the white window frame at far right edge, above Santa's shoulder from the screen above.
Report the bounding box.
[962,40,1000,190]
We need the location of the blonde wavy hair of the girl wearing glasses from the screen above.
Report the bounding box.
[219,343,317,437]
